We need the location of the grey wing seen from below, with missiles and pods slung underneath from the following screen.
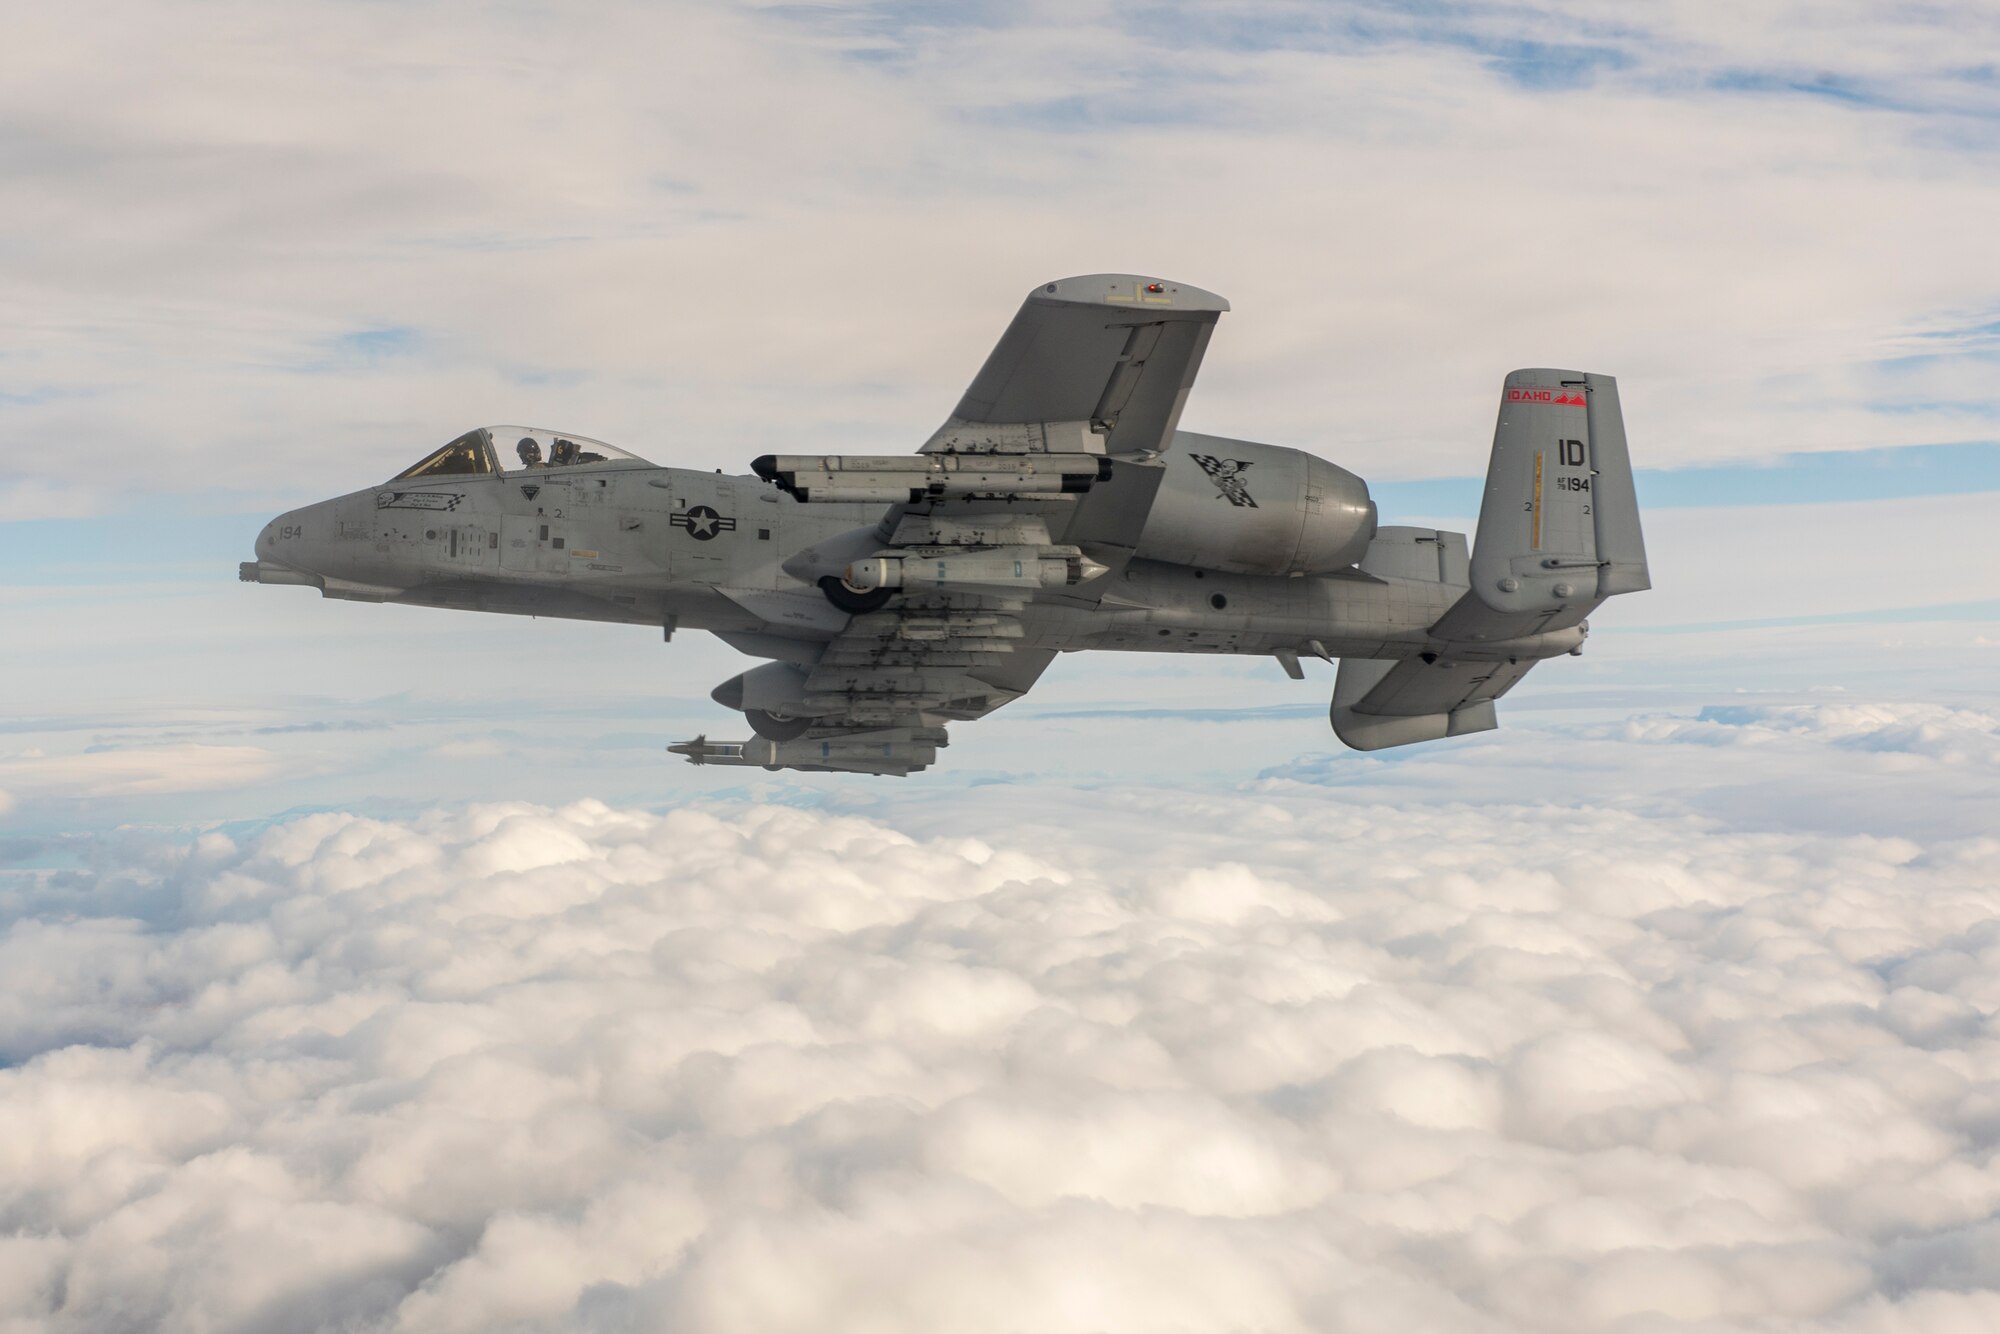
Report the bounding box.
[676,274,1228,774]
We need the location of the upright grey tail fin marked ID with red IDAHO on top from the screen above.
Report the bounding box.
[1472,370,1652,628]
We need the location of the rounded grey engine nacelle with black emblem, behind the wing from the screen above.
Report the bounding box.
[1136,430,1376,574]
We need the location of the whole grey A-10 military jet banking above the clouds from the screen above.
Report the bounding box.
[242,274,1648,774]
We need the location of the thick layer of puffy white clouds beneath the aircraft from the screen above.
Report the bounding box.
[0,704,2000,1334]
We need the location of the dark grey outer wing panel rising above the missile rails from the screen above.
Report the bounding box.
[924,274,1230,454]
